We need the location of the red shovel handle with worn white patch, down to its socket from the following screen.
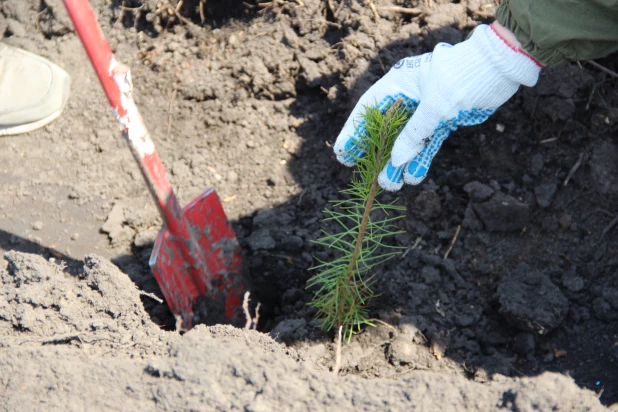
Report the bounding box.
[63,0,212,294]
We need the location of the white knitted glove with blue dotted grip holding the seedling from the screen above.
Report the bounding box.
[334,25,541,191]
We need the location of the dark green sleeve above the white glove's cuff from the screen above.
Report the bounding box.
[496,0,618,66]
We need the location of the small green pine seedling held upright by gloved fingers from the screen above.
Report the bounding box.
[308,99,412,344]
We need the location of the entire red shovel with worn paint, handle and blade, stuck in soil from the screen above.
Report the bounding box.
[63,0,247,330]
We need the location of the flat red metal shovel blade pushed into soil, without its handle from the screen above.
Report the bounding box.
[150,189,247,329]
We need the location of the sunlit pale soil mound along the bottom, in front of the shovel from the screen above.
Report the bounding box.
[0,252,603,411]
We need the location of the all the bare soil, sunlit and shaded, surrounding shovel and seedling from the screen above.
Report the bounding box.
[0,0,618,410]
